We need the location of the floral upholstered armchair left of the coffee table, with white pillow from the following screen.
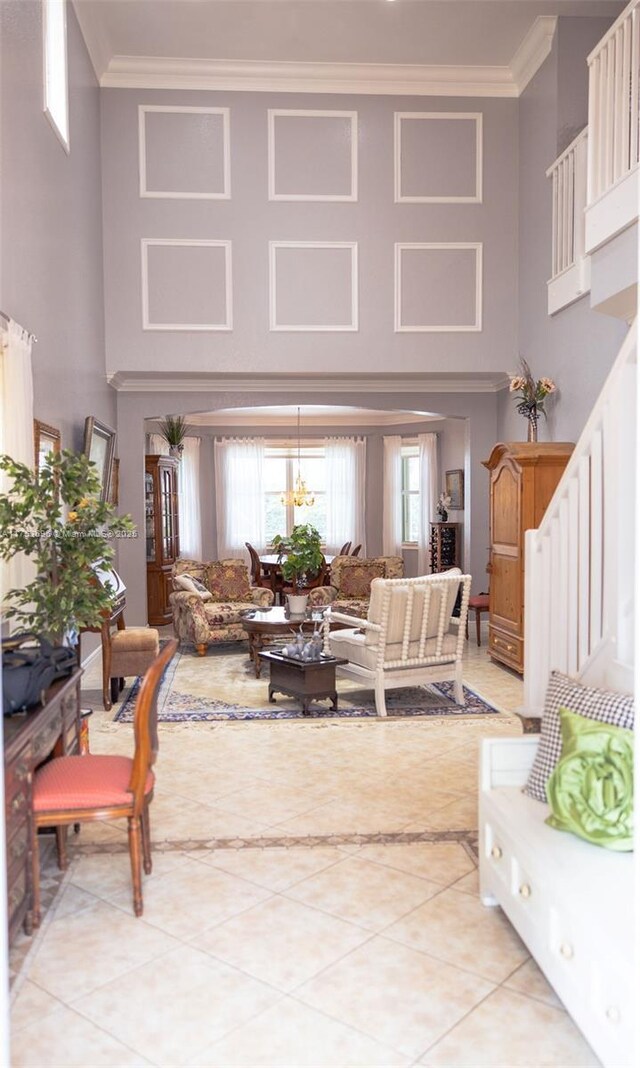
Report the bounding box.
[169,560,274,657]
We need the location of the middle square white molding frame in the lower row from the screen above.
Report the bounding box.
[269,241,358,331]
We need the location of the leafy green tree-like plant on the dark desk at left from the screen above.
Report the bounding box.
[0,450,136,645]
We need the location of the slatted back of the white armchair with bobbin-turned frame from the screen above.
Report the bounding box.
[365,567,462,647]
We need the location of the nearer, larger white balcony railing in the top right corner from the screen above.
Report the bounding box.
[588,0,640,204]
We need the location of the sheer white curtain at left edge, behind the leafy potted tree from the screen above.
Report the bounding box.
[0,319,35,603]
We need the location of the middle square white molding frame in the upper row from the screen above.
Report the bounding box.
[267,108,358,201]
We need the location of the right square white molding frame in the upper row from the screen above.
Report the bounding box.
[393,111,482,204]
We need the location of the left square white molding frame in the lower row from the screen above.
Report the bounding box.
[140,237,233,330]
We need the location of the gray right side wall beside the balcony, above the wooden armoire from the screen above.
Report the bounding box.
[498,18,626,441]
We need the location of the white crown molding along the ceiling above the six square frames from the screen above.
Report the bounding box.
[99,56,521,97]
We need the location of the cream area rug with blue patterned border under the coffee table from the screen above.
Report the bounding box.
[114,643,500,723]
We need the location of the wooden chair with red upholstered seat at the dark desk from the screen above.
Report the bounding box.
[32,638,177,927]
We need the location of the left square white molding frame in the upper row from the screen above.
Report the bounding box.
[138,104,231,200]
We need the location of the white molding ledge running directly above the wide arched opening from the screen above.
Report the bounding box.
[107,371,509,395]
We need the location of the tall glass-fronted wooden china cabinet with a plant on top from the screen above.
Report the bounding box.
[144,456,179,627]
